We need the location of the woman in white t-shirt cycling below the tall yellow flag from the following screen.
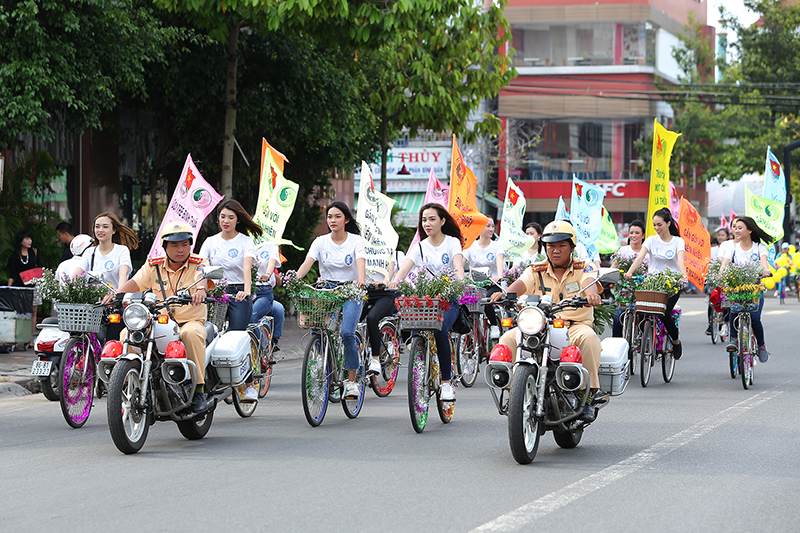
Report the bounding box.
[625,207,688,361]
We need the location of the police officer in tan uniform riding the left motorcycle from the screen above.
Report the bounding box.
[119,222,208,412]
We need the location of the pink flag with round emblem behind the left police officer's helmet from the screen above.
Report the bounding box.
[147,154,222,258]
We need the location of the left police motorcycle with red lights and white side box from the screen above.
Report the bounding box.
[98,266,252,454]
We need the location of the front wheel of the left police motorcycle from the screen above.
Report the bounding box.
[106,359,150,455]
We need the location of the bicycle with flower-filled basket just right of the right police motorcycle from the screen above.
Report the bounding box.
[636,291,681,387]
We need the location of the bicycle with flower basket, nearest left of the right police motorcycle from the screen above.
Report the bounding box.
[398,298,458,433]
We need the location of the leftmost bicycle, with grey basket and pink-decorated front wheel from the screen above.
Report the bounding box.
[56,303,111,429]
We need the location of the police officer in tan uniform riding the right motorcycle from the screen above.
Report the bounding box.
[492,220,601,422]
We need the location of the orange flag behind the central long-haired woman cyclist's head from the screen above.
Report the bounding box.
[447,134,489,250]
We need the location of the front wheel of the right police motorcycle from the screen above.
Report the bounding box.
[508,365,544,465]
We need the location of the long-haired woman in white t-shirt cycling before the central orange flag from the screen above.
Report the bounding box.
[392,203,464,402]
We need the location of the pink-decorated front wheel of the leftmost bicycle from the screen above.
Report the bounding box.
[58,337,95,429]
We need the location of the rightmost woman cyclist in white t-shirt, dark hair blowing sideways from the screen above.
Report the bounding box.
[719,217,773,363]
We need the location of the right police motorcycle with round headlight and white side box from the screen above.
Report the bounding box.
[482,268,628,464]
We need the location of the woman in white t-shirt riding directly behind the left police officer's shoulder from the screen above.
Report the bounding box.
[198,200,262,402]
